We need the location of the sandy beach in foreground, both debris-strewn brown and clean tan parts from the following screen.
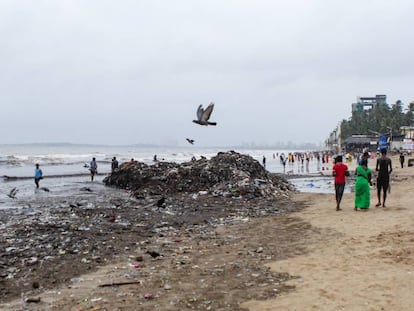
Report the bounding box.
[0,158,414,311]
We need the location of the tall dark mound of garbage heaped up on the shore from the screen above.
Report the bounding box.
[104,151,294,199]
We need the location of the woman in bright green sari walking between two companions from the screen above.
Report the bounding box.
[355,159,371,211]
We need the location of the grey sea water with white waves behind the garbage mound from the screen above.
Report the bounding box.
[0,144,333,208]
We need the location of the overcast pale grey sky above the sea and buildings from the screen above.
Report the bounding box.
[0,0,414,146]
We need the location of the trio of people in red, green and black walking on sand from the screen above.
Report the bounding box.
[332,149,392,211]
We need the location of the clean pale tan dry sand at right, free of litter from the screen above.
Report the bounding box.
[242,157,414,311]
